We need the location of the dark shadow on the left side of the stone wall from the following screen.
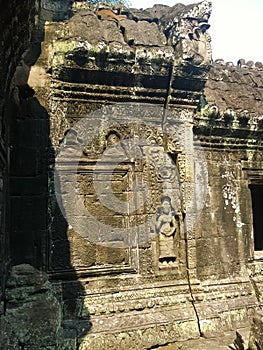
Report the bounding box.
[0,2,91,350]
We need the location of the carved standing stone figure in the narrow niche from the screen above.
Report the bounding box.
[156,196,179,265]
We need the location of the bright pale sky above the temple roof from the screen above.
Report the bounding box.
[131,0,263,64]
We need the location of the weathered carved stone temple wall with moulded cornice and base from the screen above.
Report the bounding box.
[0,1,263,350]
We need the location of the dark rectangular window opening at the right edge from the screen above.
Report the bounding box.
[249,185,263,250]
